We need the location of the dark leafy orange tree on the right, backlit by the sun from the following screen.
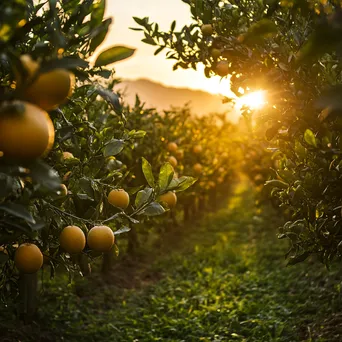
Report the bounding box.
[136,0,342,264]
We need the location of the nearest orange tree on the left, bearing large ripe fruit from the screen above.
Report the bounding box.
[0,0,195,313]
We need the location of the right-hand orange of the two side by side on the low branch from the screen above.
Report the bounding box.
[87,226,115,253]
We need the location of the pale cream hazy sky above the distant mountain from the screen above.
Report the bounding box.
[97,0,229,94]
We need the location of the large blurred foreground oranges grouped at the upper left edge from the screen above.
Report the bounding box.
[0,55,74,161]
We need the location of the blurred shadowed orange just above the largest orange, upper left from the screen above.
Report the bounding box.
[18,55,75,110]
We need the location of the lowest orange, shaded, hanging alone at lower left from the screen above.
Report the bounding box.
[14,243,43,273]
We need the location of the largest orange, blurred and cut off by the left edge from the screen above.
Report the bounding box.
[0,101,55,160]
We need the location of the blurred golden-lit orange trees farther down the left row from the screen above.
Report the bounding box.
[122,99,236,224]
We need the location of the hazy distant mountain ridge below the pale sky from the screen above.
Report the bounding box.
[116,79,237,121]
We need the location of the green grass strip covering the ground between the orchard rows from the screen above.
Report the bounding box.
[0,180,342,342]
